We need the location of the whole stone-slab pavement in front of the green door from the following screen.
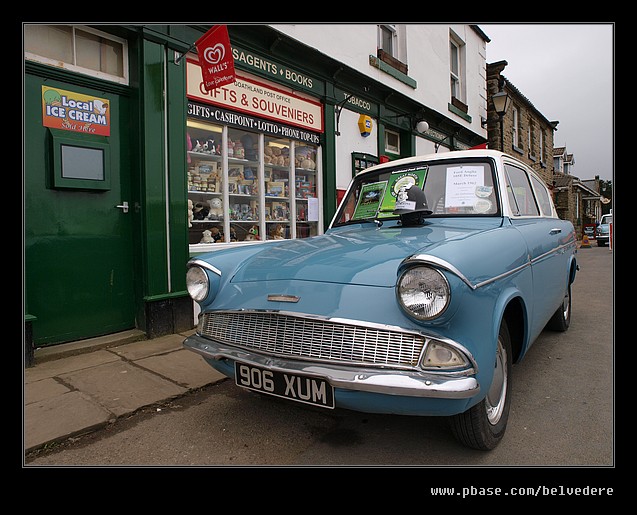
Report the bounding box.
[23,330,225,454]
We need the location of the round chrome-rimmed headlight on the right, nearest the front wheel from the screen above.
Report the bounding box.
[396,266,451,320]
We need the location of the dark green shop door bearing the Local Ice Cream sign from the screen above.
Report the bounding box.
[24,75,136,346]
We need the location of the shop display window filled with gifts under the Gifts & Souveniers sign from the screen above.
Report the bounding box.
[187,120,320,244]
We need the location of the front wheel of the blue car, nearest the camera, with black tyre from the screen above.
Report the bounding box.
[451,320,511,451]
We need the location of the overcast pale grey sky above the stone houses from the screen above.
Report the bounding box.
[479,23,615,180]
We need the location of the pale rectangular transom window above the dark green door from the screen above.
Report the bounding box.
[24,24,128,84]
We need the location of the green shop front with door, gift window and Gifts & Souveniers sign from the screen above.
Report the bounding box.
[23,25,458,362]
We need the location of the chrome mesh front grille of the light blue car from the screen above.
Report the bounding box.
[199,311,425,368]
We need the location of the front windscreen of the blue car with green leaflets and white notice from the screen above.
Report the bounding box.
[334,160,500,225]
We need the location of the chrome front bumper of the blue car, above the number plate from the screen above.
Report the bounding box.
[184,334,480,399]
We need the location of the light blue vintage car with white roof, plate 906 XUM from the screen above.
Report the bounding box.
[184,150,577,450]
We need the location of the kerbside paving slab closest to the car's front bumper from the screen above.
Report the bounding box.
[135,348,226,388]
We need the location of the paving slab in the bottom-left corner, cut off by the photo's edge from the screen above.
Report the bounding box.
[24,391,114,451]
